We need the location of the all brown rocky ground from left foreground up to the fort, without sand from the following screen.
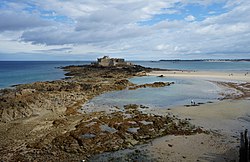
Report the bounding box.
[0,65,202,161]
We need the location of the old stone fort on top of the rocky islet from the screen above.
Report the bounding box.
[94,56,132,67]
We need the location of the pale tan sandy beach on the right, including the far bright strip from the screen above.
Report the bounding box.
[143,71,250,161]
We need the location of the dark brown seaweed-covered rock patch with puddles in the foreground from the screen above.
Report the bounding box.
[52,104,204,156]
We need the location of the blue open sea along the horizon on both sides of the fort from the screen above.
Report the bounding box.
[0,60,250,89]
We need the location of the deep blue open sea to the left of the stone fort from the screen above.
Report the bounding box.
[0,61,90,88]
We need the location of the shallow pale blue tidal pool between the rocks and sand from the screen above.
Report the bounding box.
[85,76,223,108]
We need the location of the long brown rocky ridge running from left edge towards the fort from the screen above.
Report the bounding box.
[0,66,150,122]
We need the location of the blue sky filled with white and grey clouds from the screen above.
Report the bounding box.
[0,0,250,61]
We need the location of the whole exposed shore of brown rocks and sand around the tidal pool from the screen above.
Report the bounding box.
[0,65,250,161]
